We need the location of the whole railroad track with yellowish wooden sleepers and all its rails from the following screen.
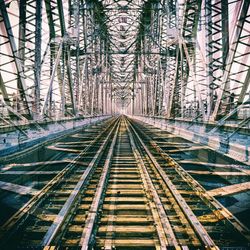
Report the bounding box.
[0,117,248,249]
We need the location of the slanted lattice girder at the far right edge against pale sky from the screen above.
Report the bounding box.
[211,1,250,120]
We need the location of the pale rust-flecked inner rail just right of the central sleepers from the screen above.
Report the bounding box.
[126,119,179,249]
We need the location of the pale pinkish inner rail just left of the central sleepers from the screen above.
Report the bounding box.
[79,119,120,250]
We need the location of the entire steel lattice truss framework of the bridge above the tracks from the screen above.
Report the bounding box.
[0,0,250,123]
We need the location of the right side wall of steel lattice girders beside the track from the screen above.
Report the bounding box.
[132,0,250,126]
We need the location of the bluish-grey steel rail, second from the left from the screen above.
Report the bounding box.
[41,118,119,247]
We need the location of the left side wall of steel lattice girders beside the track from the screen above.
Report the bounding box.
[0,0,112,125]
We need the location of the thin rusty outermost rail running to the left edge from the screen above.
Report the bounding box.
[0,117,117,246]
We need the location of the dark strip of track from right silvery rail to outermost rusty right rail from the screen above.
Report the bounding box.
[127,117,250,247]
